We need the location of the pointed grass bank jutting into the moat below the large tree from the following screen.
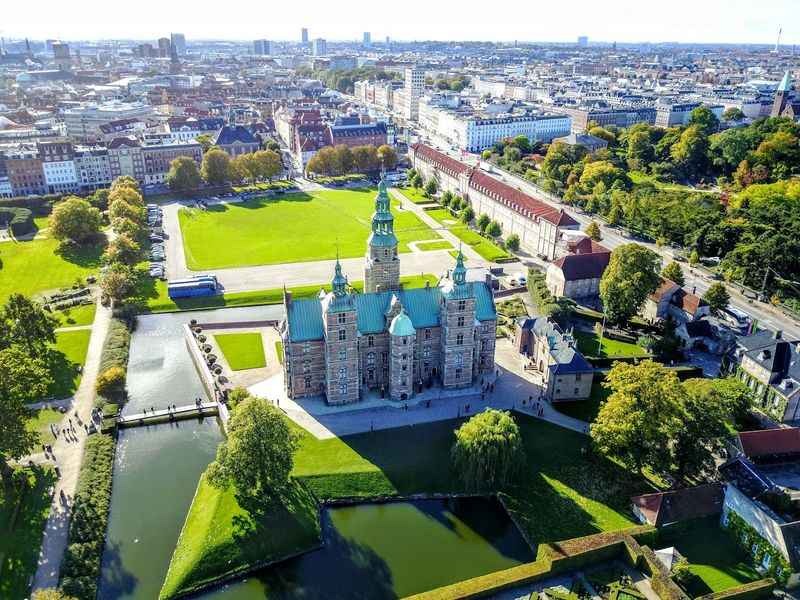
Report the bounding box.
[159,475,320,598]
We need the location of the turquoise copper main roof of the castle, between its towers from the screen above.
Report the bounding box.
[286,281,497,342]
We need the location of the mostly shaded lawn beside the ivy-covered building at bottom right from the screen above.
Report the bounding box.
[659,517,761,598]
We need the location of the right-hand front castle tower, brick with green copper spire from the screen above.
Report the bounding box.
[441,249,476,387]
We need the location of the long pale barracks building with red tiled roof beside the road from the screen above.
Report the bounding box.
[409,144,579,260]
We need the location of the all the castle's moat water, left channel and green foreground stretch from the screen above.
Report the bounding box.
[98,307,534,600]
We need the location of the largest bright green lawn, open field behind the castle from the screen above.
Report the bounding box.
[178,189,439,270]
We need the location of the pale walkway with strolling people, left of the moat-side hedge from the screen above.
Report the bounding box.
[33,303,111,590]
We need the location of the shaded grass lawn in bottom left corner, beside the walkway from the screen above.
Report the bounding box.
[0,467,56,598]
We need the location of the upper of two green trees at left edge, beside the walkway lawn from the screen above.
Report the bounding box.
[0,294,58,357]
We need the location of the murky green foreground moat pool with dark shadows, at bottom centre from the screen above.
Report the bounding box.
[203,498,535,600]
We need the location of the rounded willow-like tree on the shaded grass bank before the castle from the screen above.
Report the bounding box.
[451,409,525,490]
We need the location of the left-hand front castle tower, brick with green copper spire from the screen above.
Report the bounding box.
[322,258,360,404]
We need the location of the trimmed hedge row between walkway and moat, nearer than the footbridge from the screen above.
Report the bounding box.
[61,434,115,600]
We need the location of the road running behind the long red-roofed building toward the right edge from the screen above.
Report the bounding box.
[418,133,800,339]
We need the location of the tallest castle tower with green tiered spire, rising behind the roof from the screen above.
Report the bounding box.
[364,177,400,292]
